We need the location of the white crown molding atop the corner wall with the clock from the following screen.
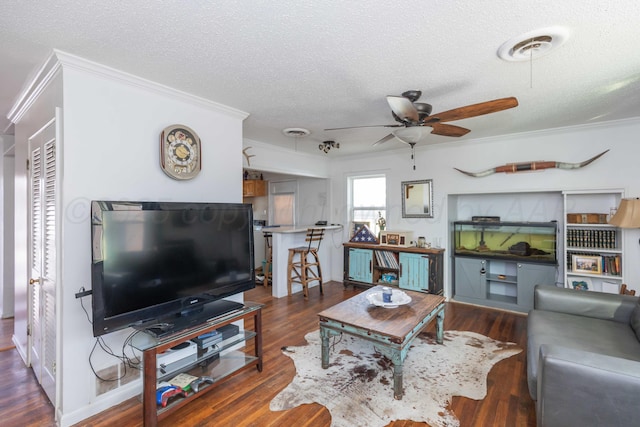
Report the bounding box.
[7,49,249,123]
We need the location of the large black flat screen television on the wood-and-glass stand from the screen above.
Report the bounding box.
[91,201,255,336]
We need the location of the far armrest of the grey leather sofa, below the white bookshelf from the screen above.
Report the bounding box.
[534,285,638,323]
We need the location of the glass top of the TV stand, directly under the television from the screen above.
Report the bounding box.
[131,301,263,351]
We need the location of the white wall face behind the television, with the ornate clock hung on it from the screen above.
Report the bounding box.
[61,62,248,421]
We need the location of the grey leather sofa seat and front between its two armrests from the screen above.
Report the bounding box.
[527,310,640,400]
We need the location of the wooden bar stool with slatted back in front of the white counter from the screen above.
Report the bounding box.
[287,228,324,298]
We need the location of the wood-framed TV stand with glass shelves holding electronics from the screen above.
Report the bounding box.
[132,302,263,426]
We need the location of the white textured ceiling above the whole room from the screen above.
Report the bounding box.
[0,0,640,156]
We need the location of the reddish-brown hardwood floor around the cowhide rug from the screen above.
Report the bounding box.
[0,282,535,427]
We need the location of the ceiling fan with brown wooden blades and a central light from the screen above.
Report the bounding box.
[325,90,518,148]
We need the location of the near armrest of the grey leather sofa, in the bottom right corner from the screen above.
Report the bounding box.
[536,345,640,427]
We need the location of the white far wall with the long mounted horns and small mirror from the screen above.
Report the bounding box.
[331,119,640,296]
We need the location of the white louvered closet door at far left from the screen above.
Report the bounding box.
[29,116,57,404]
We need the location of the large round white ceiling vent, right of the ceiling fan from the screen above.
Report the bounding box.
[498,26,569,61]
